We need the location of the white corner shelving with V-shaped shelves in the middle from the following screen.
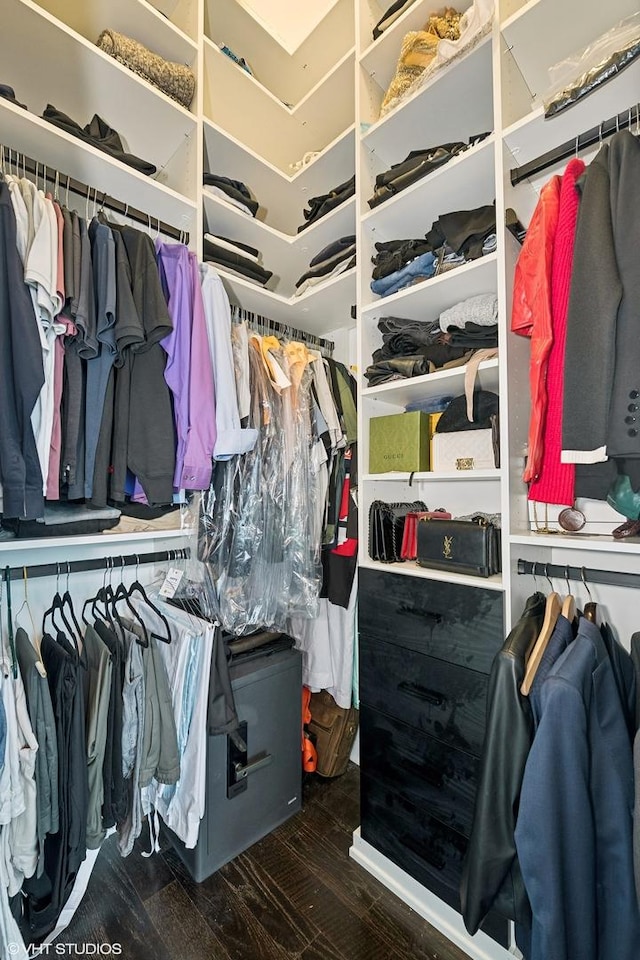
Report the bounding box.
[203,0,355,333]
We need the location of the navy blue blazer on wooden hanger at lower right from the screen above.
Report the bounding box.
[515,618,640,960]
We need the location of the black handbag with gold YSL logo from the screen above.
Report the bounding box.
[417,515,501,577]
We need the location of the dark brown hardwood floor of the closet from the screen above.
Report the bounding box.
[59,764,468,960]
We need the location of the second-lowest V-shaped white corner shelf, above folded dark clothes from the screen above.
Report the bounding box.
[203,187,355,293]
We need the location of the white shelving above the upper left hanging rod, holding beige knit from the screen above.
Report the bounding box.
[0,0,198,231]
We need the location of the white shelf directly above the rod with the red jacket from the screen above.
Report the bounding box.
[503,59,640,172]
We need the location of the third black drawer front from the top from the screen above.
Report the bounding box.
[360,707,479,837]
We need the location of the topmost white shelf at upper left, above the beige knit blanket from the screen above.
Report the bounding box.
[33,0,198,67]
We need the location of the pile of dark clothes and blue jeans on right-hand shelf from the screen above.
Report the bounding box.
[371,204,497,297]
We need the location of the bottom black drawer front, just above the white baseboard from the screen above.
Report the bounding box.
[360,775,509,947]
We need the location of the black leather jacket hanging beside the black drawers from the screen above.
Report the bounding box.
[460,593,546,934]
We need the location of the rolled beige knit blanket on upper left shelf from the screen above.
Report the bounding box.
[97,30,196,108]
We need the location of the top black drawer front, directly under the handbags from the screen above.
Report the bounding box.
[358,568,504,673]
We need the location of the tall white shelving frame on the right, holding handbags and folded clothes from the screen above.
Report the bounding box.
[351,0,640,960]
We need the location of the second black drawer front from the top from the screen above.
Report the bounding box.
[360,637,488,757]
